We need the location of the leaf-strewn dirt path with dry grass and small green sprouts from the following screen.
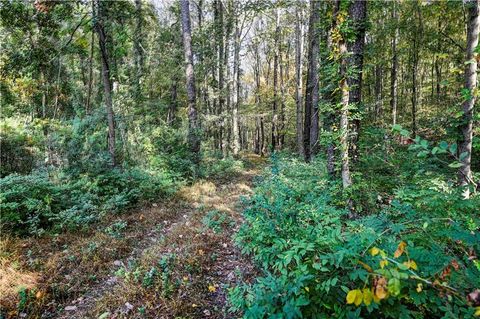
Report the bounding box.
[0,156,264,319]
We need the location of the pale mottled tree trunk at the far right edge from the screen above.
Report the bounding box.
[458,0,480,198]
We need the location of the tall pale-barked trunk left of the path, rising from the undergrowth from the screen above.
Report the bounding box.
[180,0,200,164]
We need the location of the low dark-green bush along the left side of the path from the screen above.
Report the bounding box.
[0,169,177,235]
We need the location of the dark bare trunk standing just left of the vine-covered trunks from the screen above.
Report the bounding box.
[303,0,320,162]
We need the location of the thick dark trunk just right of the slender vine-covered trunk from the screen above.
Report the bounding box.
[348,0,367,161]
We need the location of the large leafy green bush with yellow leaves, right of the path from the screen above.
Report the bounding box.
[230,158,480,318]
